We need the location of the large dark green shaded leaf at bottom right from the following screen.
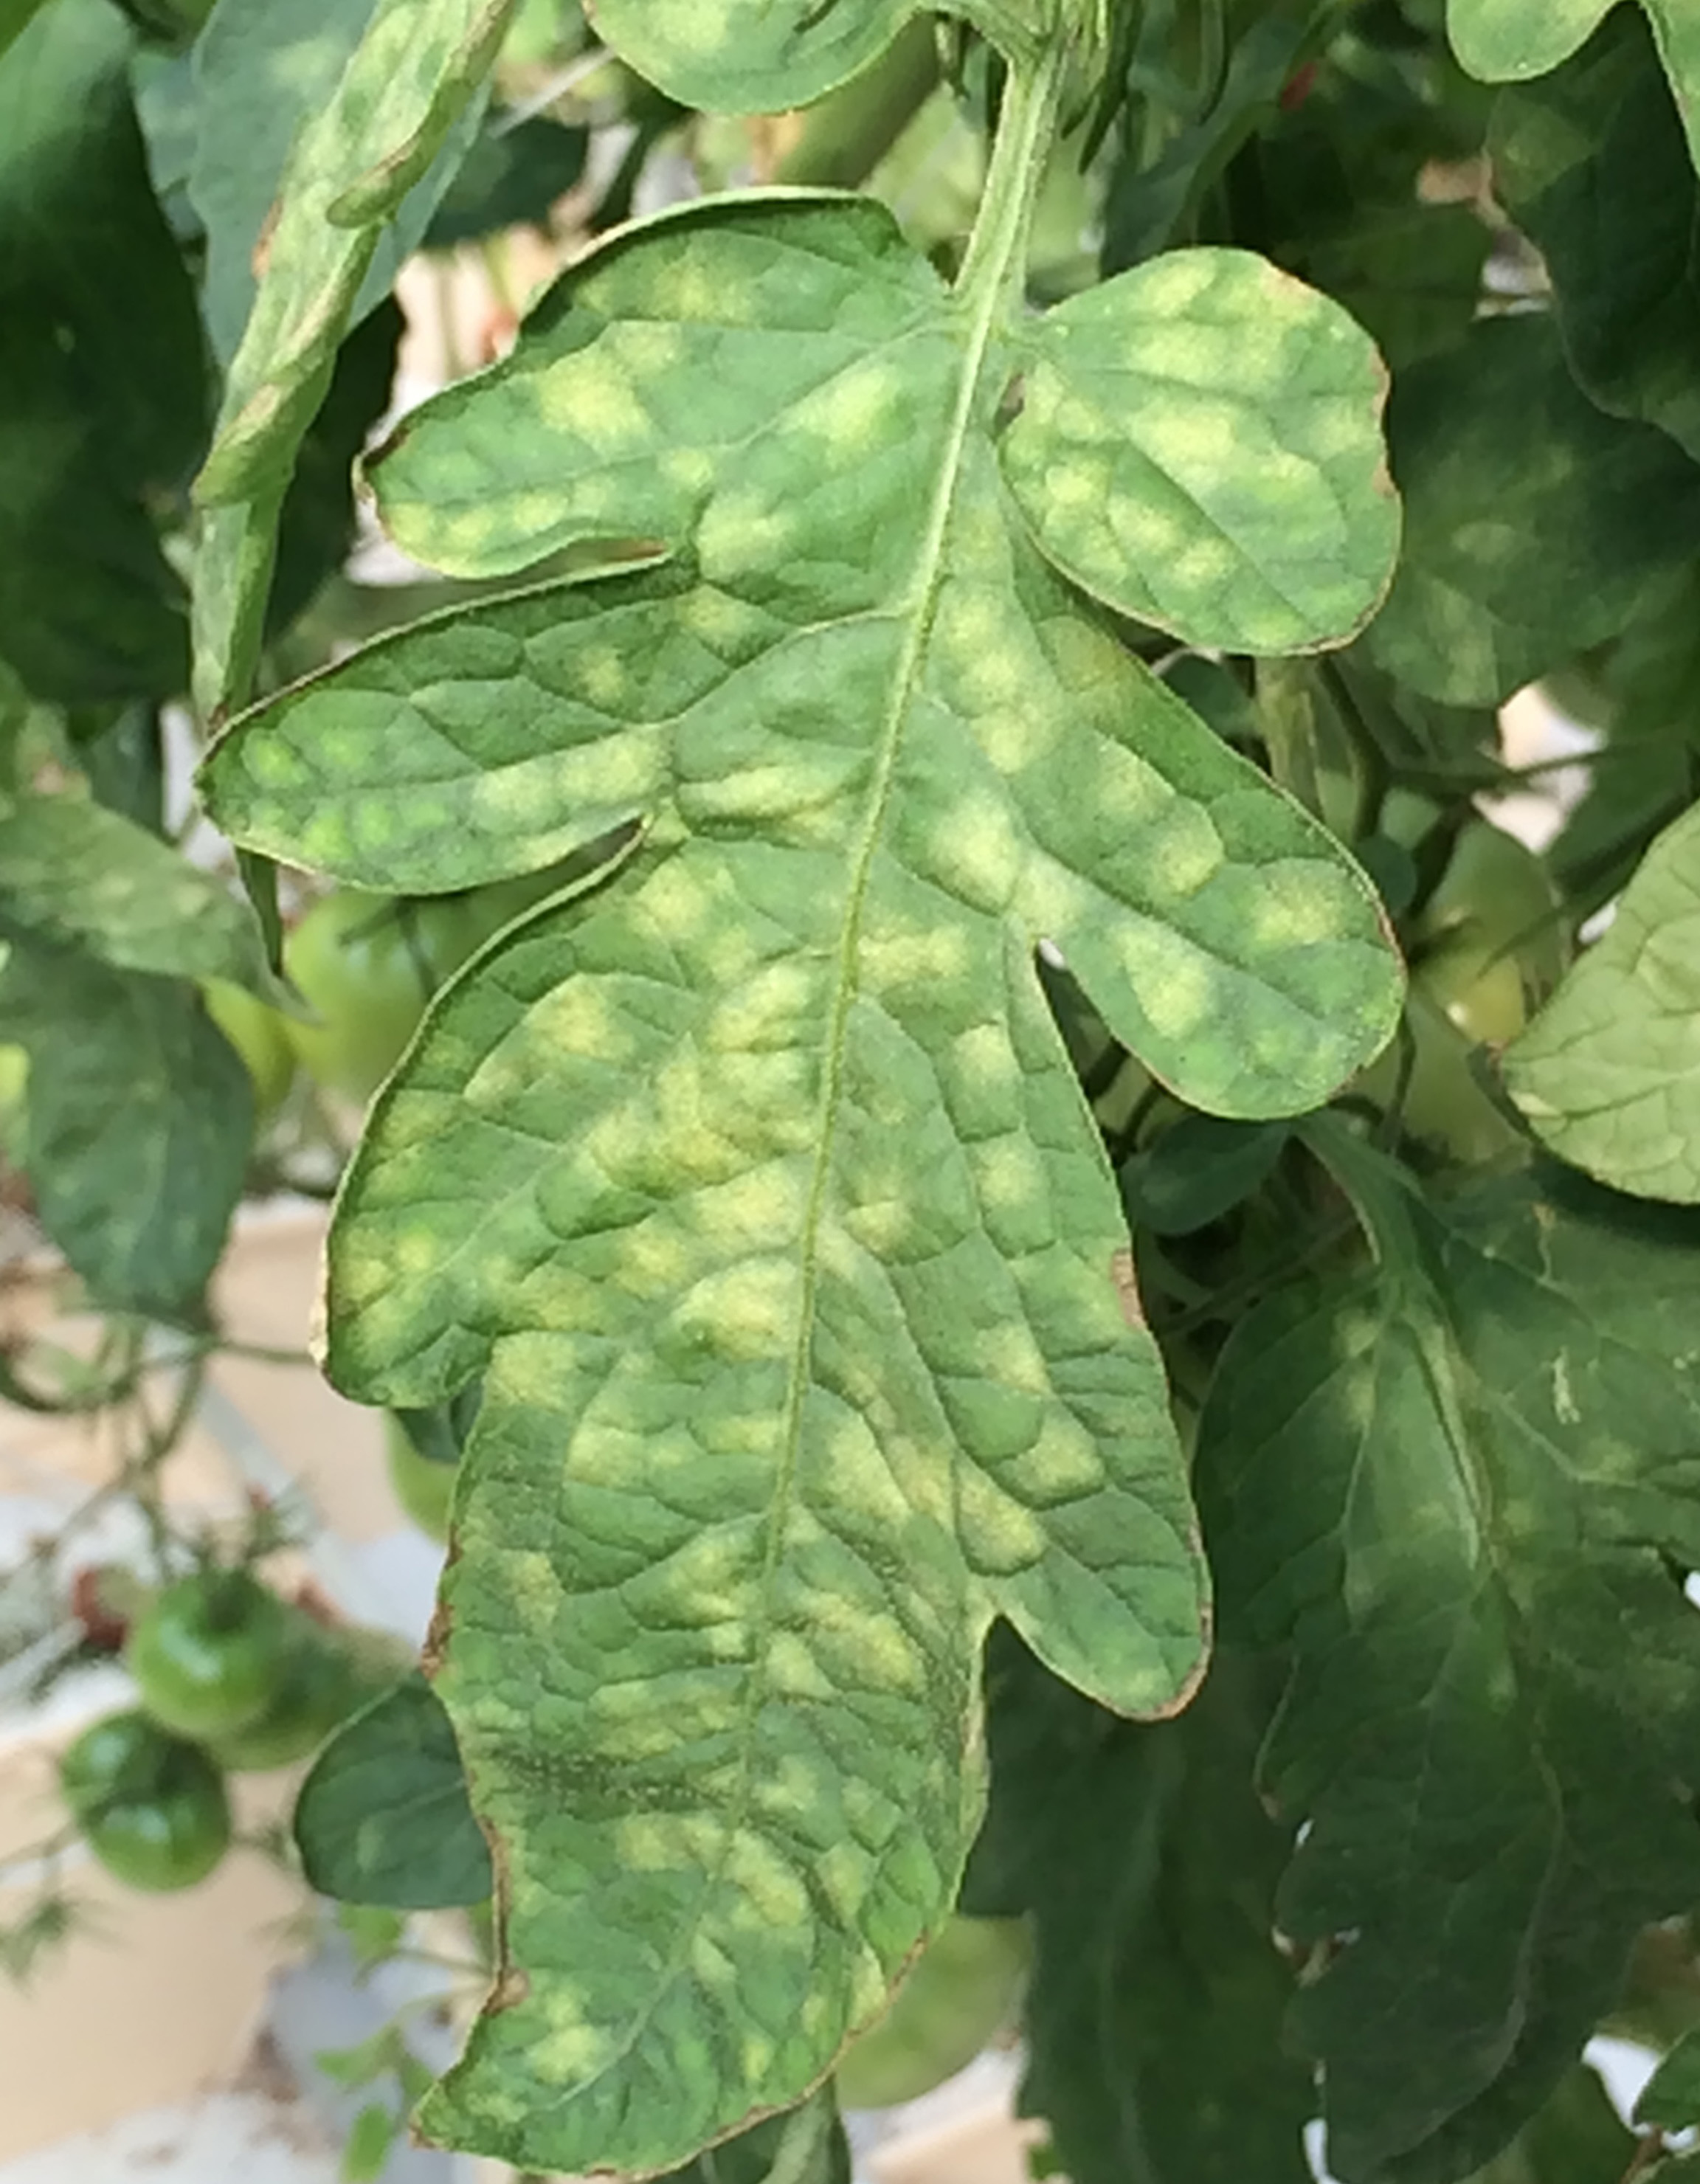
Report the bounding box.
[1198,1177,1700,2184]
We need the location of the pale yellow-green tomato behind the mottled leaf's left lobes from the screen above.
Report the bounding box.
[284,887,481,1101]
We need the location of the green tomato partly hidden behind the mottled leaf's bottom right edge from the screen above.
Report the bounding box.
[837,1913,1032,2107]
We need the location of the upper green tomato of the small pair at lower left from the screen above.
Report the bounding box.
[125,1570,291,1738]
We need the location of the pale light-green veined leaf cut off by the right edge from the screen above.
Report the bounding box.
[1503,810,1700,1206]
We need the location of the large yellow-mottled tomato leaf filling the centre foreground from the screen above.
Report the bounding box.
[207,145,1398,2171]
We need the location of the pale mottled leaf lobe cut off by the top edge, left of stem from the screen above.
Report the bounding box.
[596,0,925,114]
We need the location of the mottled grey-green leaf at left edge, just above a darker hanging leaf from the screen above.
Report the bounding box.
[0,795,271,994]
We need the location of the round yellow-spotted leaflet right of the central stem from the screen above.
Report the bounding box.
[1003,249,1398,653]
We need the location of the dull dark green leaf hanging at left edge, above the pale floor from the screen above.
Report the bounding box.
[0,935,254,1319]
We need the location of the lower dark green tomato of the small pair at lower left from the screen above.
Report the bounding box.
[59,1710,229,1891]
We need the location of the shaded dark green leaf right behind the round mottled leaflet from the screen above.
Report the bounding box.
[1364,317,1700,705]
